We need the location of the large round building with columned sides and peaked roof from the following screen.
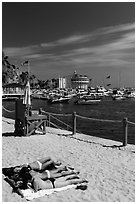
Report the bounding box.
[71,71,89,90]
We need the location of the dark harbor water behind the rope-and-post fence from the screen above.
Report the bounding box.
[2,97,135,144]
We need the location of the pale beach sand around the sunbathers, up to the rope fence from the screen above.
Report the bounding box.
[2,118,135,202]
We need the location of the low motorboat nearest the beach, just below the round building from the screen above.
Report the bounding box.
[74,98,101,105]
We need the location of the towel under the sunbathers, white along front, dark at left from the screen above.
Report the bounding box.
[2,165,87,200]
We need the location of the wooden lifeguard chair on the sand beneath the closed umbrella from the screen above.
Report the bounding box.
[14,99,47,136]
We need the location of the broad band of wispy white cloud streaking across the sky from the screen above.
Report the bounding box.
[4,23,135,75]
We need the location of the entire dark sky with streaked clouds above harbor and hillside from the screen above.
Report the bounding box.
[2,2,135,87]
